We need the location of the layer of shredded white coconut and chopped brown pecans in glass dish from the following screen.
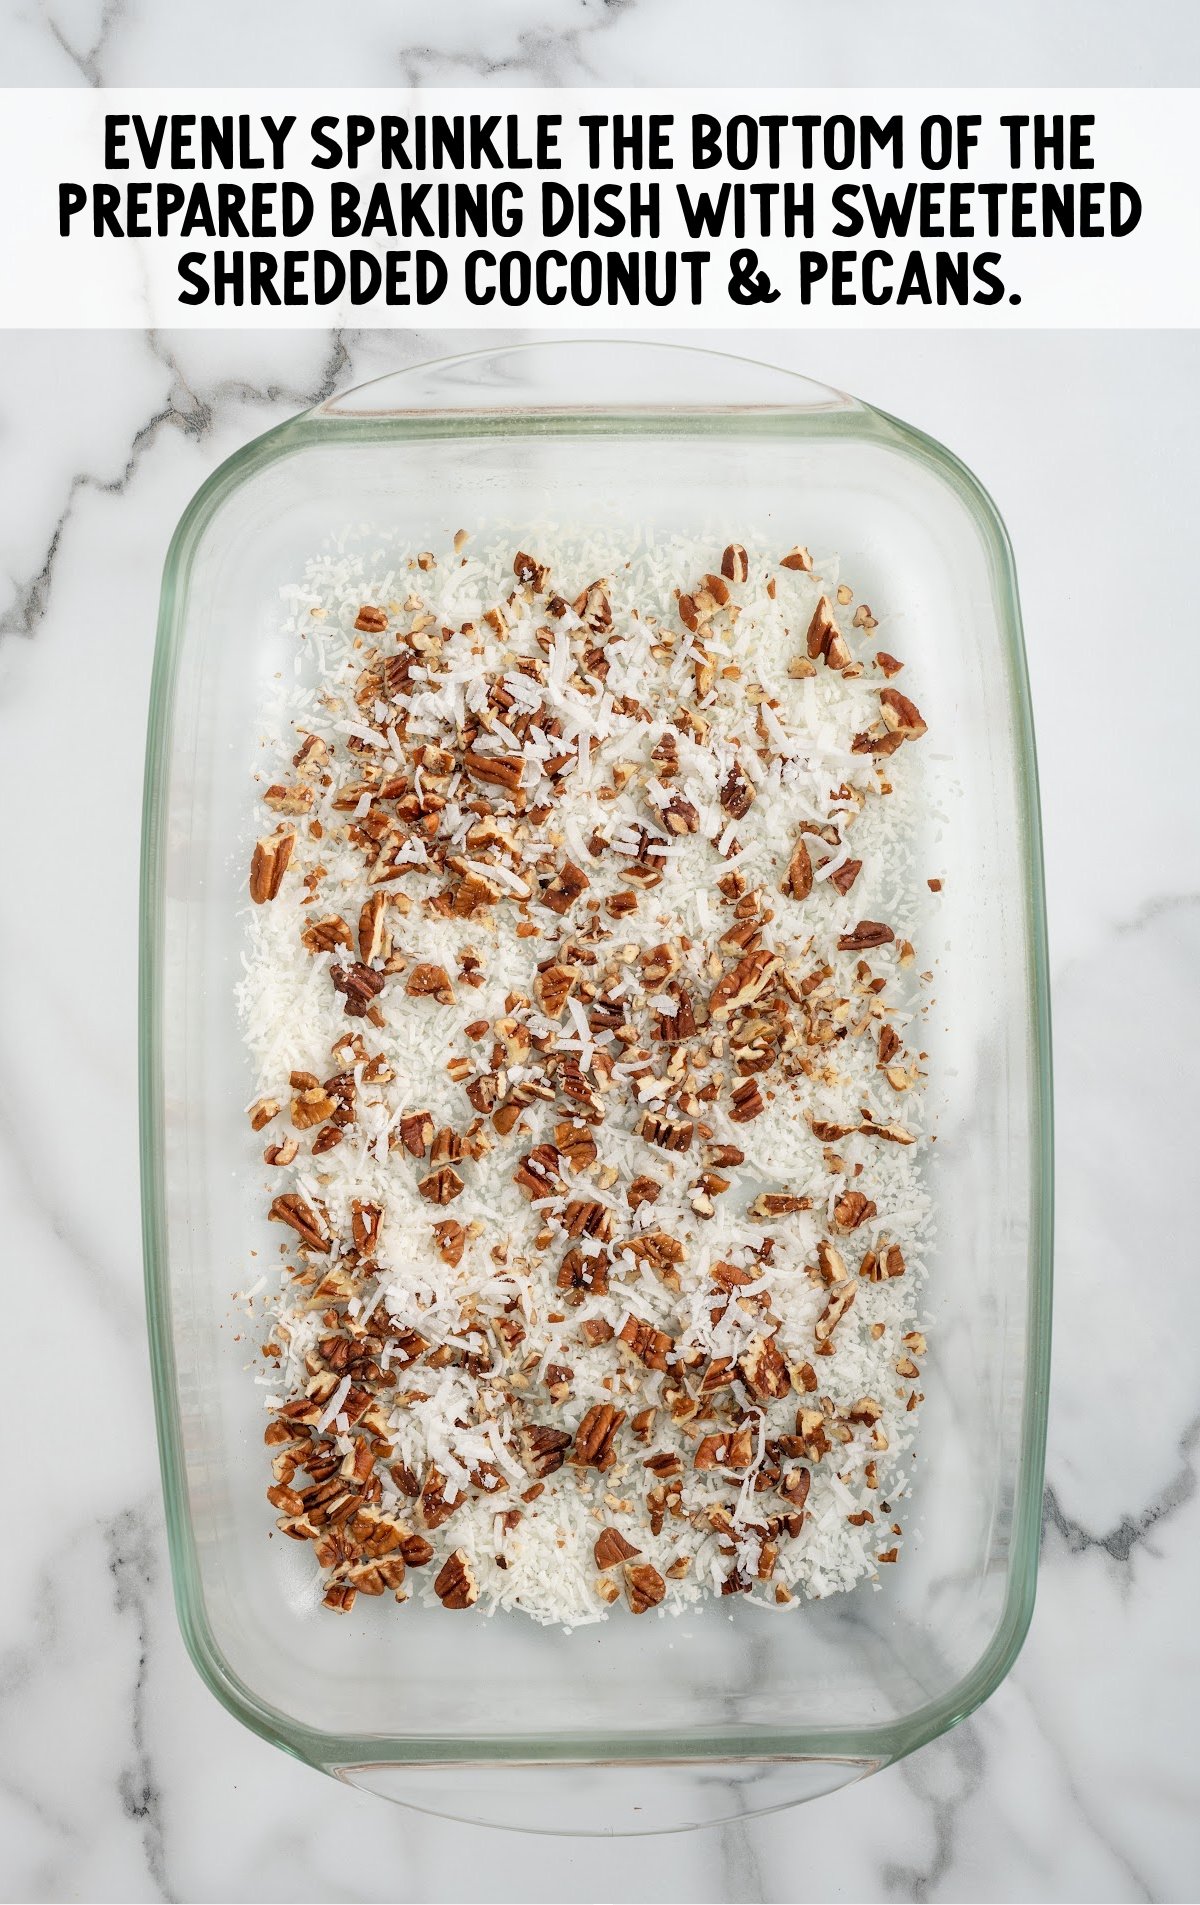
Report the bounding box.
[240,531,930,1625]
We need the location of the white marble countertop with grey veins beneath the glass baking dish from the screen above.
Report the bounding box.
[0,0,1200,1901]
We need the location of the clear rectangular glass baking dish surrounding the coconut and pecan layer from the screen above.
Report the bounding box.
[141,341,1051,1833]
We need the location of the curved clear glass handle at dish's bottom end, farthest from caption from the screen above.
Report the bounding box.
[326,1756,884,1838]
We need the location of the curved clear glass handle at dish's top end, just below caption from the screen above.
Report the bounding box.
[309,337,863,423]
